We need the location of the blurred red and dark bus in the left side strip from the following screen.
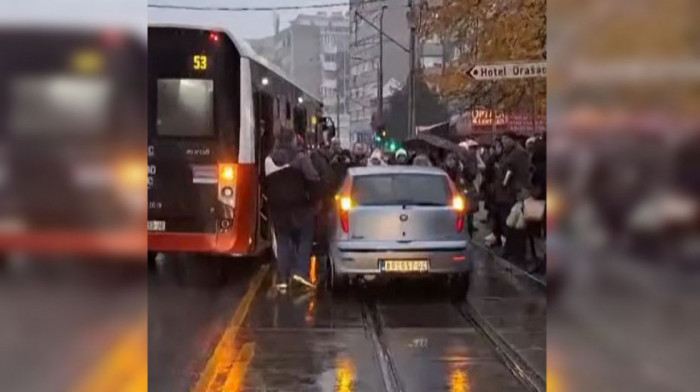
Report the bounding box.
[0,27,147,256]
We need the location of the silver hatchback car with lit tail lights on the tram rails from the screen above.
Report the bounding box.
[327,166,471,296]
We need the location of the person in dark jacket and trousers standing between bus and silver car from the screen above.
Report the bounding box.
[265,129,320,290]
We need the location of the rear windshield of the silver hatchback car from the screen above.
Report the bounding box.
[351,174,450,206]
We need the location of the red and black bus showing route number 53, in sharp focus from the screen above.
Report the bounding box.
[148,24,322,255]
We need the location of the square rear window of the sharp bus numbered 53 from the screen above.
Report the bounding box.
[156,79,214,137]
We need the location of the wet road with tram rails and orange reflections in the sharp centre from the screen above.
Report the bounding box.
[148,248,546,392]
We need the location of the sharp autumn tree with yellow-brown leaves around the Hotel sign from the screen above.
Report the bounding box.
[420,0,547,114]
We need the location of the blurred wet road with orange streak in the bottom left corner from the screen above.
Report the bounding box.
[0,257,148,392]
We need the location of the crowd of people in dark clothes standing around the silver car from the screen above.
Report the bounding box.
[264,130,546,290]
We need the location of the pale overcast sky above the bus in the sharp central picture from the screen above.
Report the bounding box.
[148,0,348,38]
